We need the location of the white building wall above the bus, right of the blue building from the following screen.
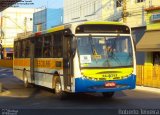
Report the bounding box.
[64,0,102,23]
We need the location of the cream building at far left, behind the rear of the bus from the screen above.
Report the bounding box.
[0,8,35,58]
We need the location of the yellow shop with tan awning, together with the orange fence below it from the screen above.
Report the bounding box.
[137,5,160,88]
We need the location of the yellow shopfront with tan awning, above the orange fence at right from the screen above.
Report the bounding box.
[137,6,160,65]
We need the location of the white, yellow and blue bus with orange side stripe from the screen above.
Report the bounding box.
[13,21,136,98]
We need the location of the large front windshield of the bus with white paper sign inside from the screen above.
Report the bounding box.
[77,36,133,68]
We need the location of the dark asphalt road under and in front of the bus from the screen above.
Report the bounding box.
[0,68,160,115]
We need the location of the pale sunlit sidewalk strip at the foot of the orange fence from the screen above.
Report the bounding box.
[135,86,160,93]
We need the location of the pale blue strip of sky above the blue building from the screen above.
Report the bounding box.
[14,0,63,8]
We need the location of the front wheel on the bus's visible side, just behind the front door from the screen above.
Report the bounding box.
[54,76,66,100]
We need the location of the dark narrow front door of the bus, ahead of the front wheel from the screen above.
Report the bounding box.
[63,36,73,90]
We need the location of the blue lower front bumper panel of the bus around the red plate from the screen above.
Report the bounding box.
[75,74,136,92]
